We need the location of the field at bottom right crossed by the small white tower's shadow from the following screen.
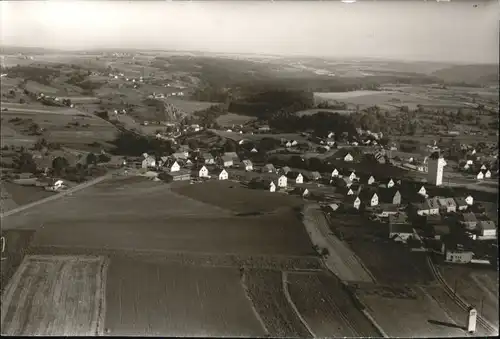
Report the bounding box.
[357,286,466,338]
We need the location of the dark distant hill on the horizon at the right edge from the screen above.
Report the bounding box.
[432,65,499,84]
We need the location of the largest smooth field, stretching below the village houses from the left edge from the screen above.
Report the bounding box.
[2,181,314,256]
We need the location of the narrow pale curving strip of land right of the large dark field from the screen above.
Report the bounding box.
[303,204,374,283]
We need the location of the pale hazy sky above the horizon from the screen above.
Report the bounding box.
[0,0,500,63]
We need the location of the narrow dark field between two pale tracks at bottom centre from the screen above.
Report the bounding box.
[243,270,312,338]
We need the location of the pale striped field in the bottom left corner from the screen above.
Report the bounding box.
[1,256,105,336]
